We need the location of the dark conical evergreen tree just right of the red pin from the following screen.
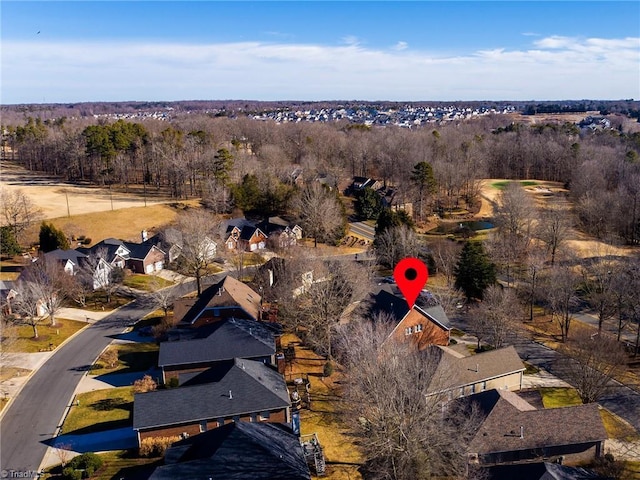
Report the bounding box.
[454,242,497,300]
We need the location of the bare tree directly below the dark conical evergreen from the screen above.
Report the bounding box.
[469,285,522,349]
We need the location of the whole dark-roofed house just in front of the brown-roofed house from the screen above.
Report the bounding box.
[158,318,284,383]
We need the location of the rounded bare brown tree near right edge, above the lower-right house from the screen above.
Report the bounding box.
[557,331,627,403]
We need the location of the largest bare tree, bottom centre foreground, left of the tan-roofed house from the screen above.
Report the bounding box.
[339,322,479,480]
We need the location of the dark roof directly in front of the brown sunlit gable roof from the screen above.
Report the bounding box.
[158,318,277,367]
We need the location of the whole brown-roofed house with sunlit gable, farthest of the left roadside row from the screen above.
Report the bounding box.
[173,275,262,328]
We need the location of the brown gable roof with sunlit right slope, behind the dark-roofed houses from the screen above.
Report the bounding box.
[180,275,262,324]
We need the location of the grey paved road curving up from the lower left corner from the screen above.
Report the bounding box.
[0,282,195,471]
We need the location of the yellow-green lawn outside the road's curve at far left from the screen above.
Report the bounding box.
[6,318,88,353]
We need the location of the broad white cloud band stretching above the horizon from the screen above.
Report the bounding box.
[2,36,640,103]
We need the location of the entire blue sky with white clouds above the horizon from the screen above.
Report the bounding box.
[0,0,640,105]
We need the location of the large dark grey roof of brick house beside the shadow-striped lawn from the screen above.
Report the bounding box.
[133,359,291,430]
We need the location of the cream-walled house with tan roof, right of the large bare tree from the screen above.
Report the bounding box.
[428,346,525,401]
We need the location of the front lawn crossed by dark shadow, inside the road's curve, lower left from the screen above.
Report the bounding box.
[62,387,133,434]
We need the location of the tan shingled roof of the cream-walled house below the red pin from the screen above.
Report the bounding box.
[429,346,525,393]
